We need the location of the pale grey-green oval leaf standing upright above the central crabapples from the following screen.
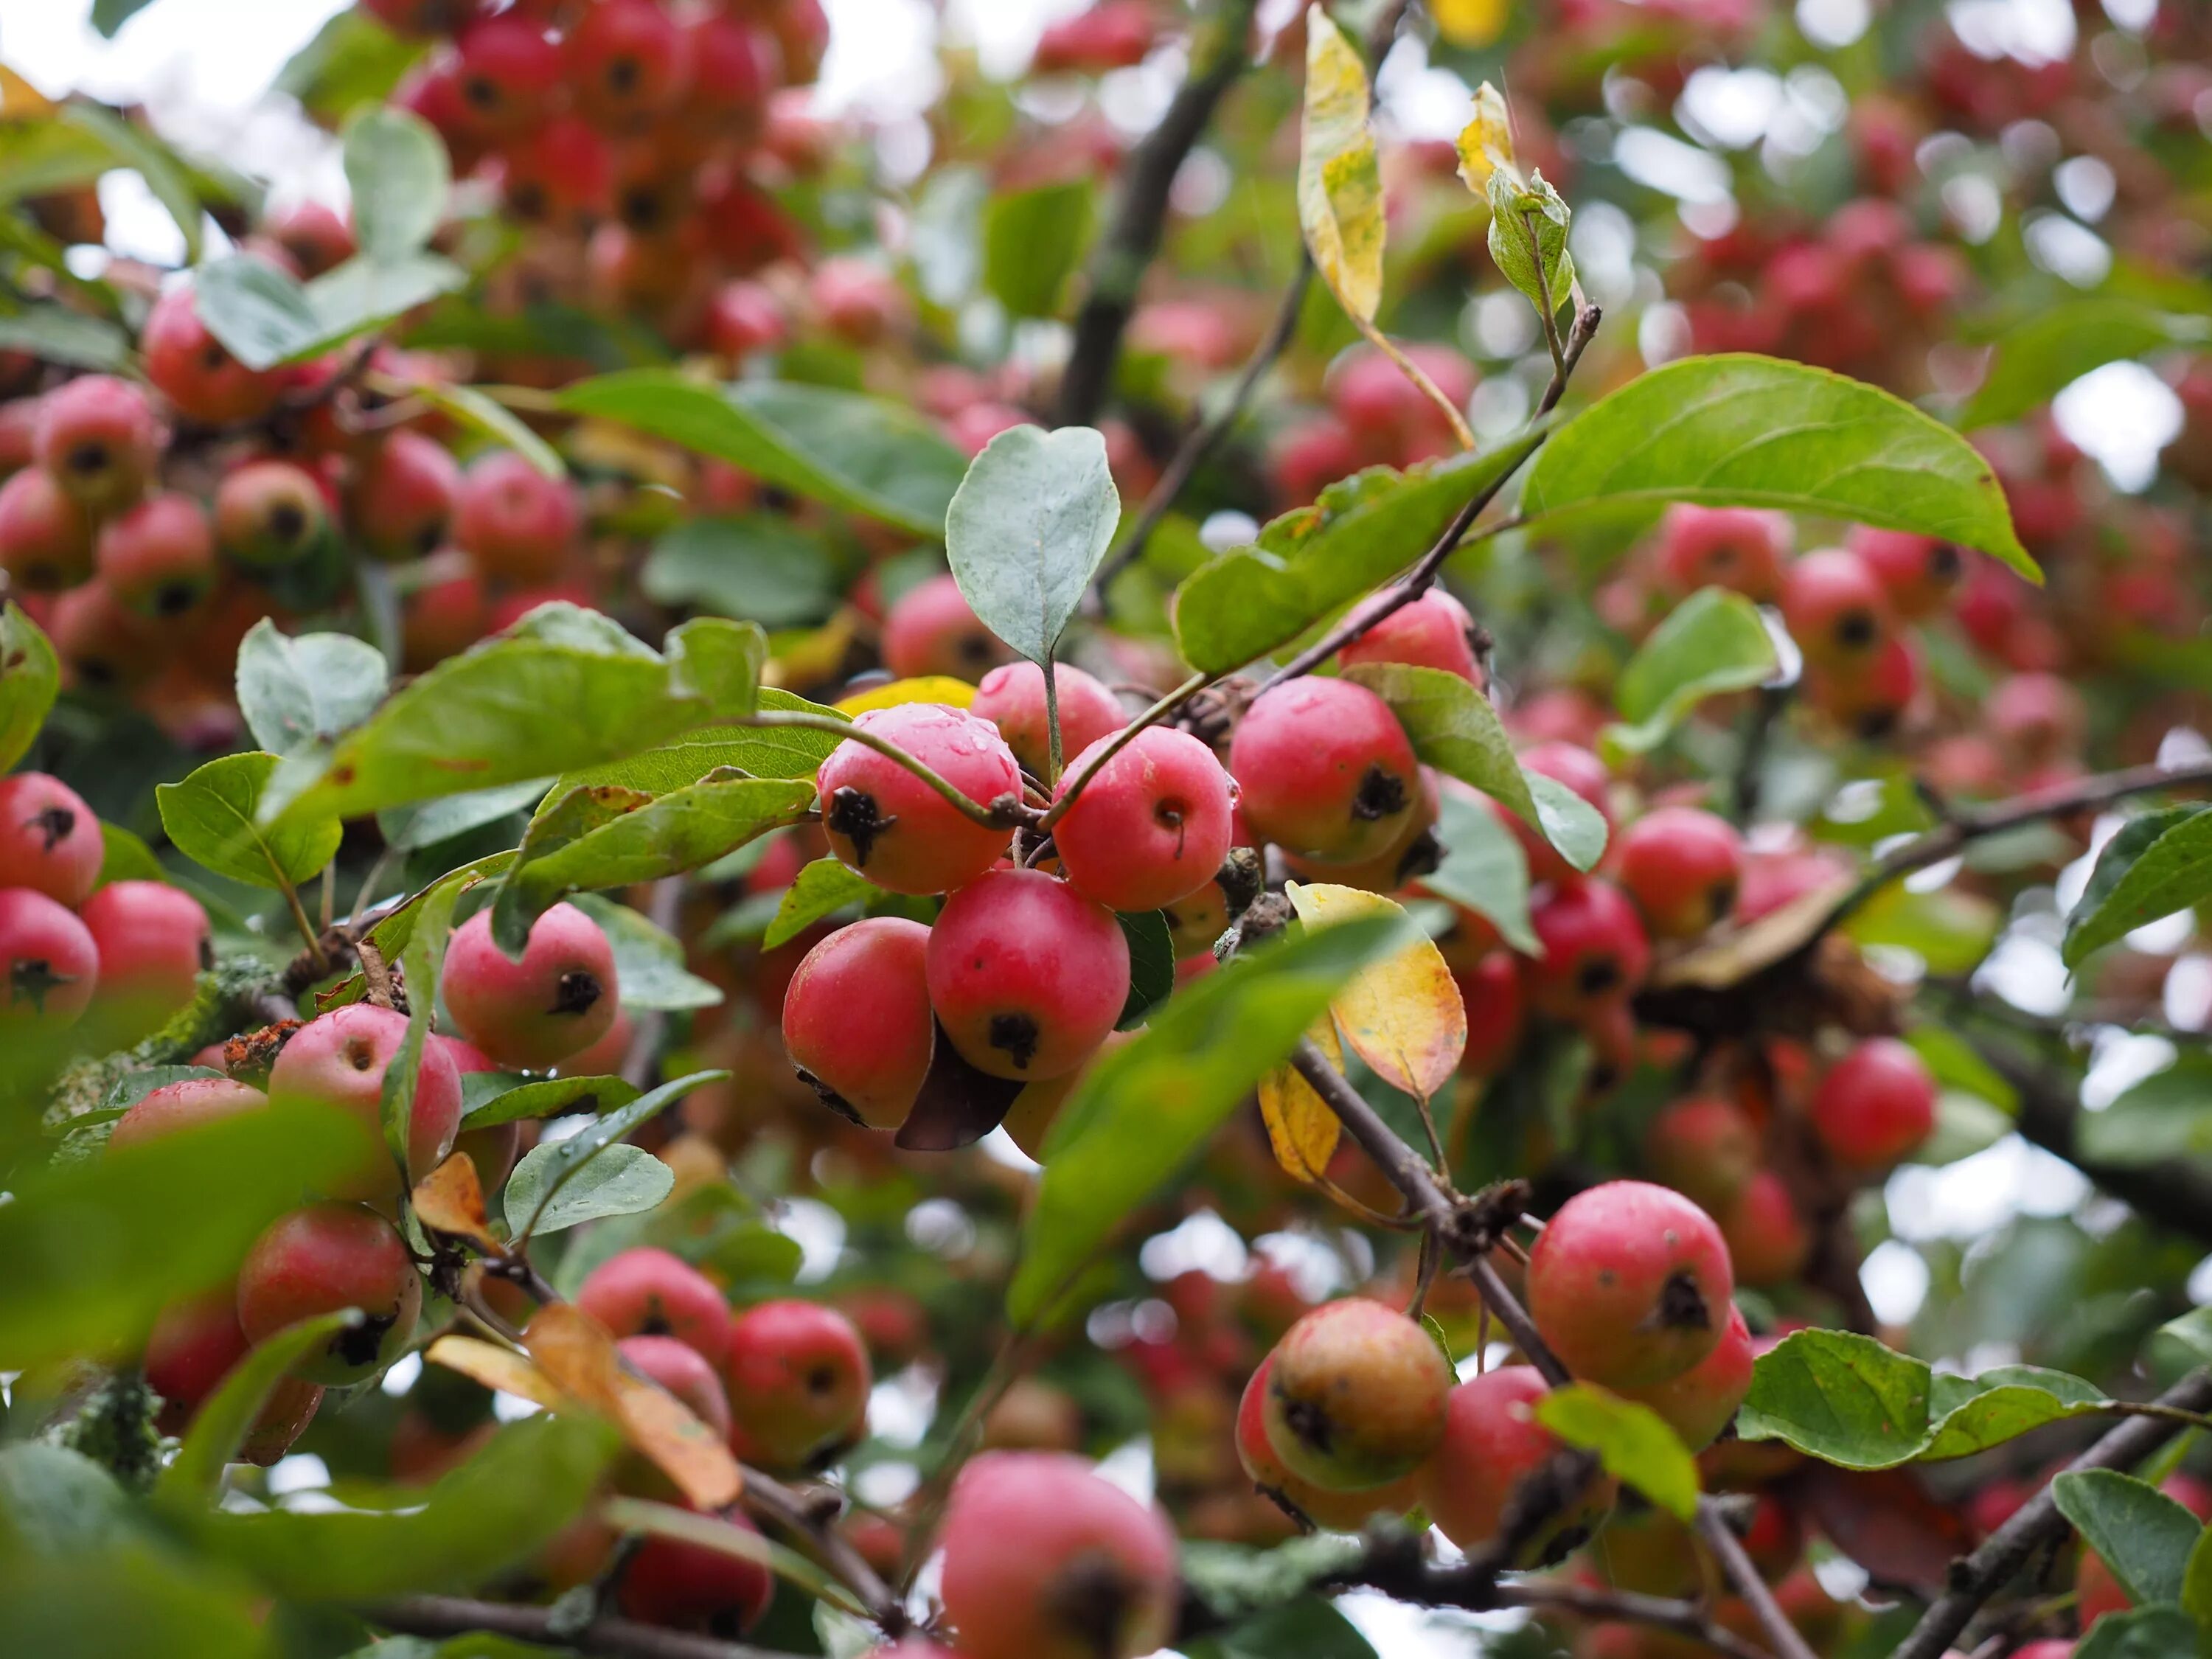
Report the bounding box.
[945,427,1121,664]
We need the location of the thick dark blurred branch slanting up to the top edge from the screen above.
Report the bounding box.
[1060,0,1259,427]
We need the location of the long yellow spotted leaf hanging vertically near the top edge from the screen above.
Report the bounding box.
[1298,4,1382,323]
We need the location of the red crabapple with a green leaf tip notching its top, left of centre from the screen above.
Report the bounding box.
[438,905,622,1071]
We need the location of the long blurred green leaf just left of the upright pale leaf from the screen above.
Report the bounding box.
[560,369,967,535]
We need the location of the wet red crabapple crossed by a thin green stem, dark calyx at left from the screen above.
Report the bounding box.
[814,703,1022,894]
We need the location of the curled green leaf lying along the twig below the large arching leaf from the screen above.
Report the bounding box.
[1175,442,1544,675]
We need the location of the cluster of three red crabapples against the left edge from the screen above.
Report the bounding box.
[0,772,212,1044]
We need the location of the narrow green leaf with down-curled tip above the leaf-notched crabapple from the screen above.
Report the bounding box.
[491,772,814,956]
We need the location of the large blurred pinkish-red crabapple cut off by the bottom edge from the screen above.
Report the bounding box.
[940,1451,1177,1659]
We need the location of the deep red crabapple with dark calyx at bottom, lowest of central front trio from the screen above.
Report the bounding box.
[925,869,1128,1082]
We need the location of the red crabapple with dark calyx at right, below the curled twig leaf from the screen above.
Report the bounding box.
[1230,677,1420,863]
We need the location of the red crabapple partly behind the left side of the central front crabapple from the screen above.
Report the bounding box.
[783,916,936,1128]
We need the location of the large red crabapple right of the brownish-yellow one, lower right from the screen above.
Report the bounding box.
[1528,1181,1734,1387]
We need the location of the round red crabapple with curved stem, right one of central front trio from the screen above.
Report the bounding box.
[1053,726,1237,911]
